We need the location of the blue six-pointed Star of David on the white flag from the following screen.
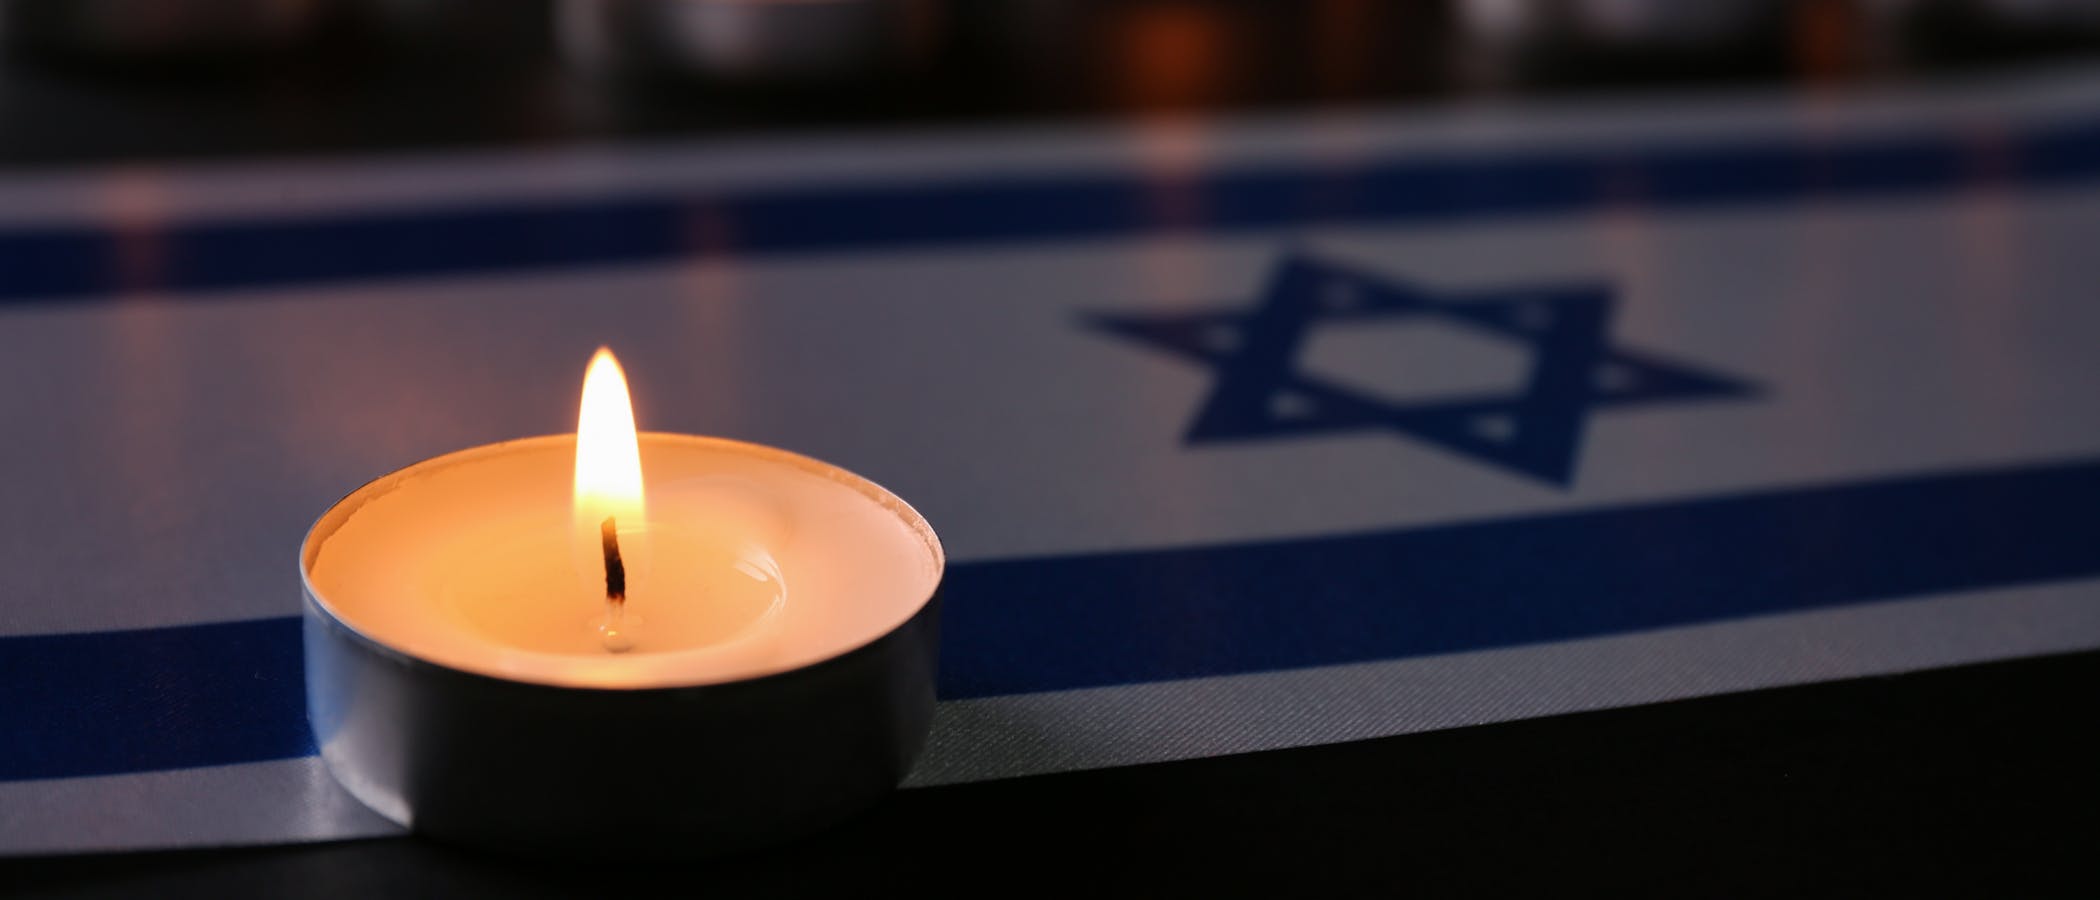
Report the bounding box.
[1092,256,1756,487]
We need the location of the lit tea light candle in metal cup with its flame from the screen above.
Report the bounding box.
[302,350,943,856]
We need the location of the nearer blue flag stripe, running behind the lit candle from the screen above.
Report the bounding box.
[0,462,2100,780]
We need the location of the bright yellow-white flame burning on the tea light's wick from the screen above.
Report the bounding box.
[575,346,643,526]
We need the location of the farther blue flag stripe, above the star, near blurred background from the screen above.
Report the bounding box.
[0,120,2100,302]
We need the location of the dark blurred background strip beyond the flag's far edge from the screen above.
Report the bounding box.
[0,0,2100,168]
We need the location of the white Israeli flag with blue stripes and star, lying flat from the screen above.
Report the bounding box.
[0,66,2100,854]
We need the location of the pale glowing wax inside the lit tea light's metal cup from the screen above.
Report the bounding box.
[302,432,943,688]
